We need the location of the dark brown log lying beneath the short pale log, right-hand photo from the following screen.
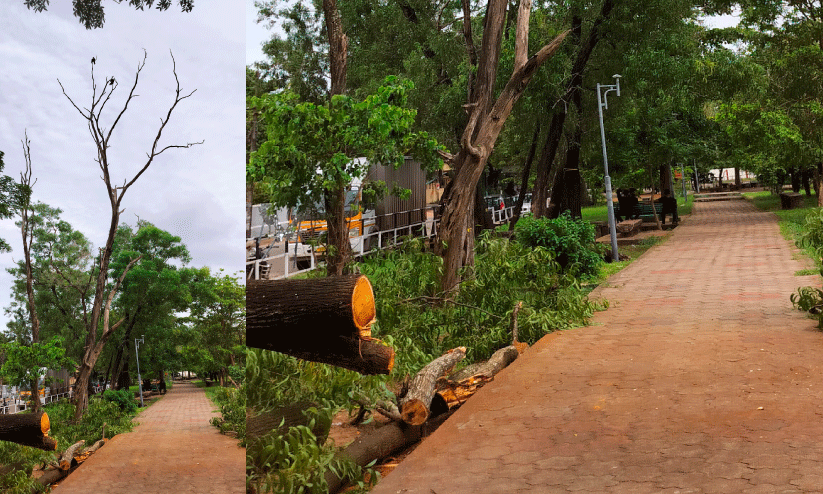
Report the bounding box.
[325,414,449,494]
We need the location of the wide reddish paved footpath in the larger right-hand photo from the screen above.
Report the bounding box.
[372,200,823,494]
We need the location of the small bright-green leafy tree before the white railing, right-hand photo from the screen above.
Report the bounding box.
[247,77,440,274]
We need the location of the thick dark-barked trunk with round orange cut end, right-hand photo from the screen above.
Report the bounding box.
[246,275,394,374]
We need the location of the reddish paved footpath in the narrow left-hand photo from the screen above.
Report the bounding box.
[52,381,246,494]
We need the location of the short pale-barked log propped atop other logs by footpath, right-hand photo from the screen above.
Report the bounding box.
[400,347,466,425]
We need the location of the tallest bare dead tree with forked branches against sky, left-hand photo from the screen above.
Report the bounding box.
[58,50,203,421]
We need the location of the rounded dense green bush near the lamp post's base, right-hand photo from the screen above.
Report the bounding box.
[515,212,603,277]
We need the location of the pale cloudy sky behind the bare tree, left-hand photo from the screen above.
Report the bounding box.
[0,0,246,330]
